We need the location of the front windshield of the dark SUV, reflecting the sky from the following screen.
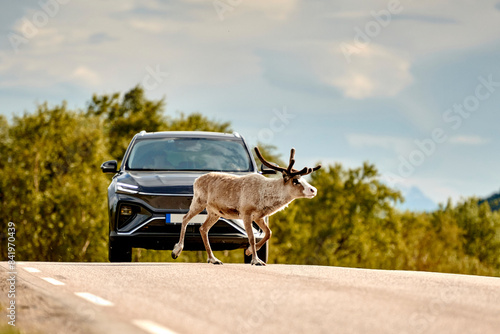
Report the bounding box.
[126,138,252,172]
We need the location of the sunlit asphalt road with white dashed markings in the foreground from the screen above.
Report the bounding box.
[0,262,500,334]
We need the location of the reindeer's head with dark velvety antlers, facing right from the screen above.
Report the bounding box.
[255,147,321,198]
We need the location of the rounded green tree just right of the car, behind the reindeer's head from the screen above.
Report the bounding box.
[271,163,401,267]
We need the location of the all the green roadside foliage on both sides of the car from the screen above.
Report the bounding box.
[0,86,500,276]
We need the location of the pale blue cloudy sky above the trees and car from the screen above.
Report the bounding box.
[0,0,500,209]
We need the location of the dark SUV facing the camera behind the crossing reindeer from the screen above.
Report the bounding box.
[101,131,268,262]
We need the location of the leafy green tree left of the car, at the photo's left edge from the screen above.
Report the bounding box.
[0,104,108,261]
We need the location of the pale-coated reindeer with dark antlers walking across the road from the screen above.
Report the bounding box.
[172,147,321,266]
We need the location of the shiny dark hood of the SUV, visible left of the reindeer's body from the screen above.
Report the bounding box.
[116,172,204,195]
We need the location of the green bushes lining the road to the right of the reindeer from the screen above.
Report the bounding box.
[270,163,500,276]
